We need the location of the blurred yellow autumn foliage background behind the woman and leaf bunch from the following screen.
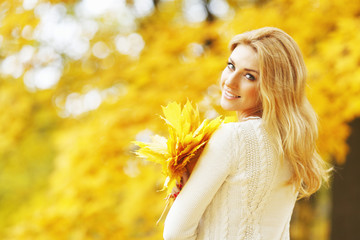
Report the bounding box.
[0,0,360,240]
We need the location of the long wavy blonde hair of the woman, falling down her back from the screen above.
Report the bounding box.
[230,27,329,198]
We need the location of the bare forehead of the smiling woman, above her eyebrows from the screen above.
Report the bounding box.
[230,44,259,71]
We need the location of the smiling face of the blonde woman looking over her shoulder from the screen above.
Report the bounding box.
[220,44,261,119]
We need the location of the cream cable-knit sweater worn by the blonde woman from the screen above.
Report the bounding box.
[164,118,297,240]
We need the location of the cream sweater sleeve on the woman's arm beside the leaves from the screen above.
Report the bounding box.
[163,124,236,240]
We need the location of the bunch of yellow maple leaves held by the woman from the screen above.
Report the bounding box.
[134,101,223,200]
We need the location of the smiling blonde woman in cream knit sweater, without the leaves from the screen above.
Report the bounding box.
[164,27,328,240]
